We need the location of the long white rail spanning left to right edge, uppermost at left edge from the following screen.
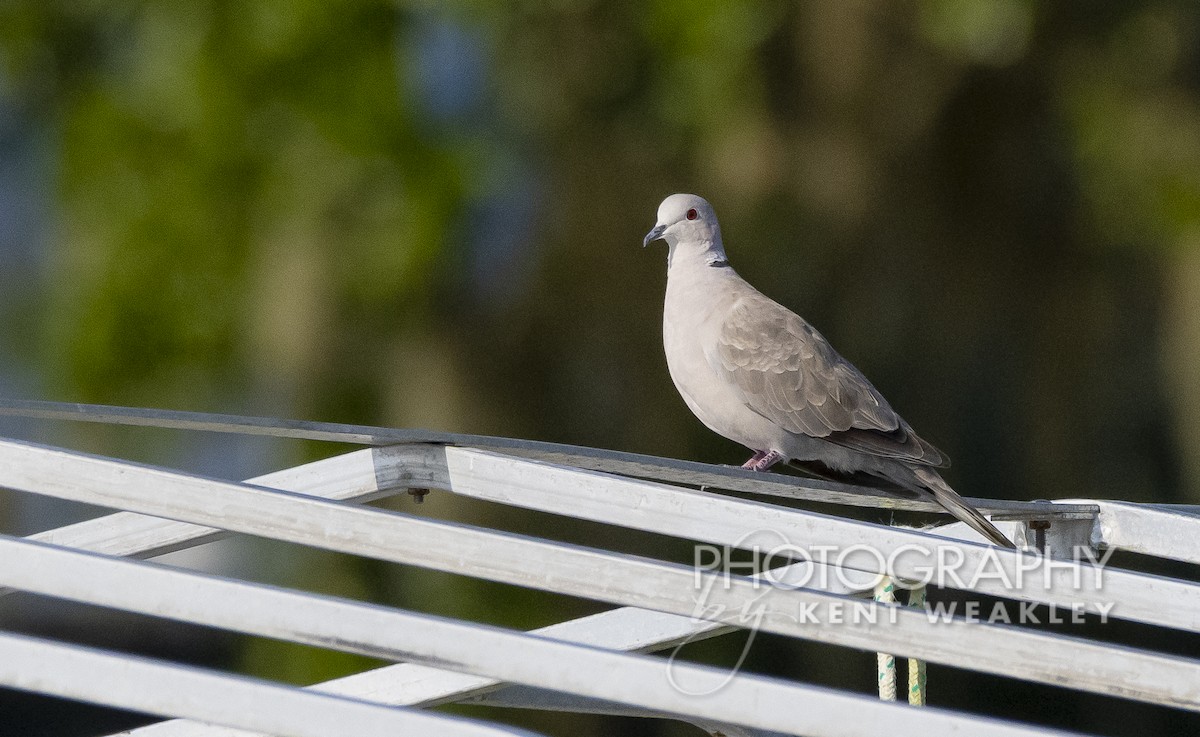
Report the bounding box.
[0,441,1200,711]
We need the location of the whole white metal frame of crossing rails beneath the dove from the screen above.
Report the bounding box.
[0,401,1200,737]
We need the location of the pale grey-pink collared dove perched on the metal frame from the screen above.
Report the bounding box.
[642,194,1014,547]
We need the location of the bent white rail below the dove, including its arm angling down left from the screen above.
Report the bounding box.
[4,445,1200,631]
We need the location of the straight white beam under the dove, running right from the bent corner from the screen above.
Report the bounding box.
[432,447,1200,631]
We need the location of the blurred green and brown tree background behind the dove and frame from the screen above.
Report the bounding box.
[0,0,1200,735]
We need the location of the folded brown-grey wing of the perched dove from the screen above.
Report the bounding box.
[707,288,946,466]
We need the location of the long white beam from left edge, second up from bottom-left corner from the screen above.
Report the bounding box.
[0,537,1080,737]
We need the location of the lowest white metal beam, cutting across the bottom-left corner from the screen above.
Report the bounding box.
[0,633,533,737]
